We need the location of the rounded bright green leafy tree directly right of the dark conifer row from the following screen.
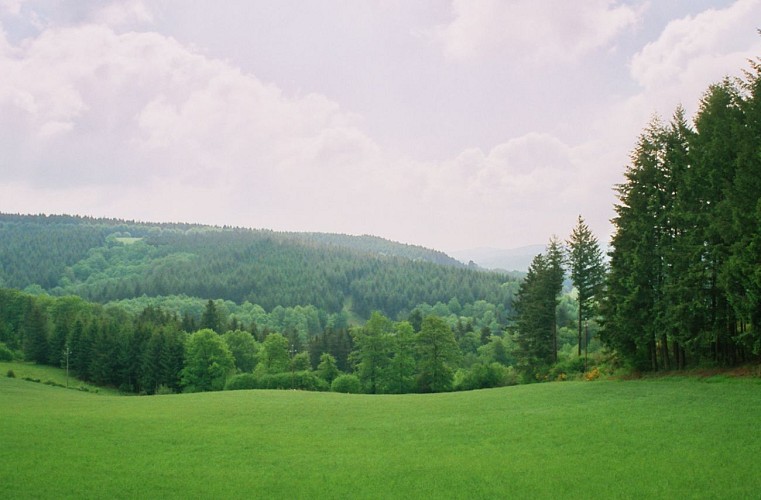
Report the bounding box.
[182,329,235,392]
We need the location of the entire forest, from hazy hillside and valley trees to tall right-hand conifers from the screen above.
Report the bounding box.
[0,57,761,394]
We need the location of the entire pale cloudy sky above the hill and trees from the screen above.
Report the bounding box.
[0,0,761,252]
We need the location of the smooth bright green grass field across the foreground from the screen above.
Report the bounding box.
[0,376,761,499]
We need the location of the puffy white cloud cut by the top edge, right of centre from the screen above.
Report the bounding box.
[432,0,642,63]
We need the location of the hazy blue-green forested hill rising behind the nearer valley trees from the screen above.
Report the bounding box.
[0,214,517,317]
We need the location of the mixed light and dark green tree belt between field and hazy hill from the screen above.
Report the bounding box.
[0,289,528,394]
